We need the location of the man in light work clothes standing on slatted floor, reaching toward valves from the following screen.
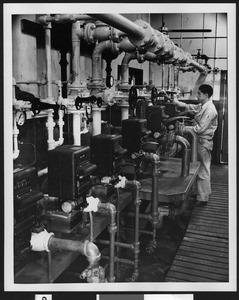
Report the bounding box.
[173,84,218,206]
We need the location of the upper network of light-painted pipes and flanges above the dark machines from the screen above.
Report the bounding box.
[13,14,208,159]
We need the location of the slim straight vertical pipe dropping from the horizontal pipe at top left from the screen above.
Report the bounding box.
[45,23,52,98]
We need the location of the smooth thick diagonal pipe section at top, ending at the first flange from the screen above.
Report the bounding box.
[89,14,145,39]
